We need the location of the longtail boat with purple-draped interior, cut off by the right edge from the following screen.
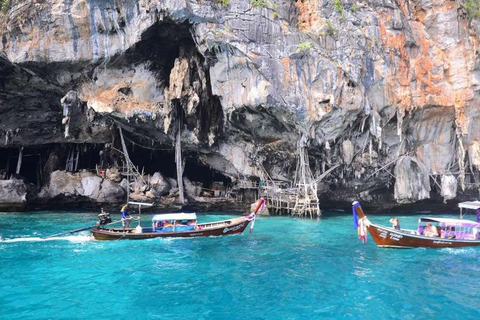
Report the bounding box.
[352,201,480,248]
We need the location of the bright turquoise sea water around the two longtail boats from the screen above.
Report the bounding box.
[0,212,480,320]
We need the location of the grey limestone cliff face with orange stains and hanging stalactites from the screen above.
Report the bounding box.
[0,0,480,211]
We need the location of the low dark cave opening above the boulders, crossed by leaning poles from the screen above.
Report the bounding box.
[0,144,232,188]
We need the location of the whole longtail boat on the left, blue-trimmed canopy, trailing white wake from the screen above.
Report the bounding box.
[92,198,265,240]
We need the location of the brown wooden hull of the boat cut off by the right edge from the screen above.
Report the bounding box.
[367,224,480,248]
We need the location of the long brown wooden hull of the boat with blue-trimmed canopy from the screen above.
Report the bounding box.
[92,217,250,240]
